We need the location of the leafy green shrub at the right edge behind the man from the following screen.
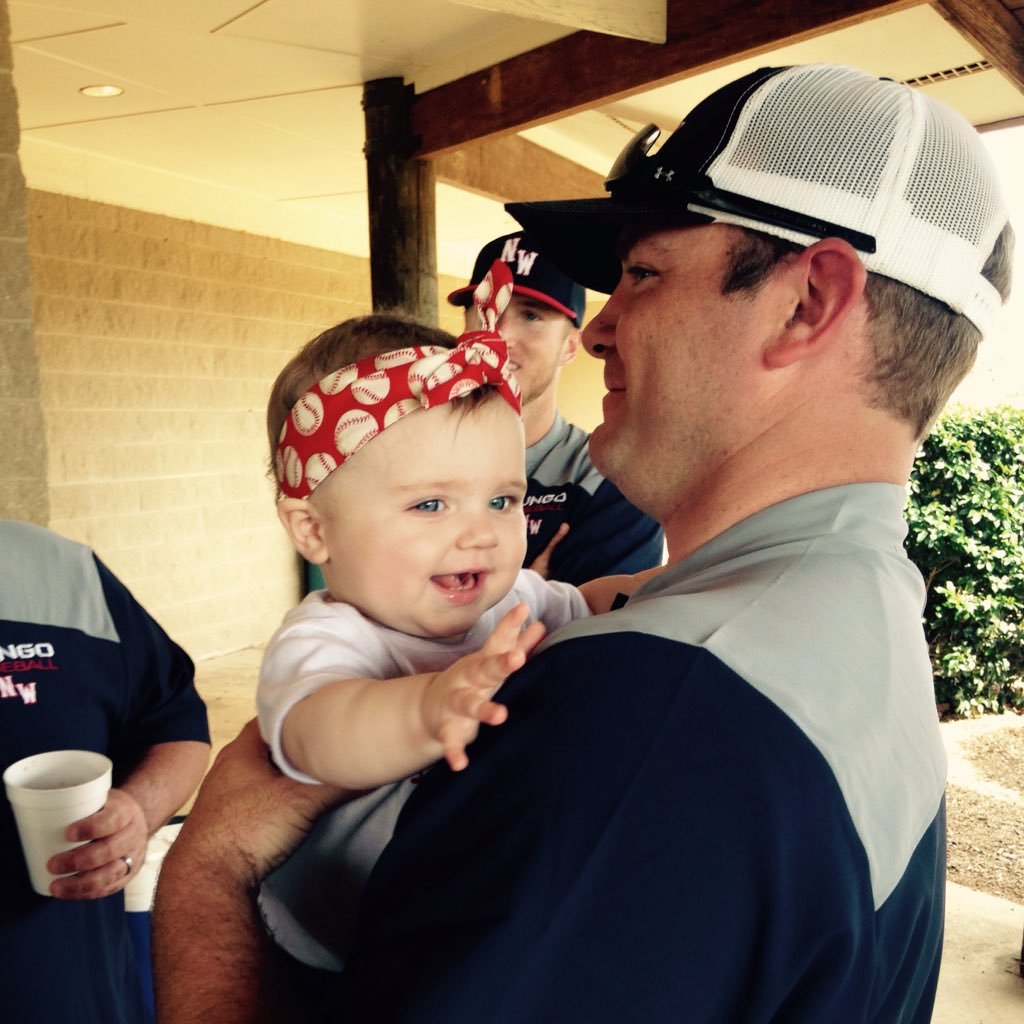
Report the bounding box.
[906,408,1024,717]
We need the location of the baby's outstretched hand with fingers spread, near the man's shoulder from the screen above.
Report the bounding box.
[423,604,546,771]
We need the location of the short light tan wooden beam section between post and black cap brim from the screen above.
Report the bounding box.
[431,135,604,203]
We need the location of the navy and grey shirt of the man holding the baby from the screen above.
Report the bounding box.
[332,484,945,1024]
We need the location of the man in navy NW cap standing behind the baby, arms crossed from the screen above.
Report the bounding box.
[447,231,665,587]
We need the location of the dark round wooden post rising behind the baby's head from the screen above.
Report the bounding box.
[362,78,437,324]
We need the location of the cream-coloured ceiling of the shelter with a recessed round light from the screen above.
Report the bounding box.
[8,0,1024,273]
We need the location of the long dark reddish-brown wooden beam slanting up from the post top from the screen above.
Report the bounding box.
[412,0,917,158]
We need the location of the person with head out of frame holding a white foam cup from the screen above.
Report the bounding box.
[0,519,210,1024]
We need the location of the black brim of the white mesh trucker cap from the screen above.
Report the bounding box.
[505,198,711,292]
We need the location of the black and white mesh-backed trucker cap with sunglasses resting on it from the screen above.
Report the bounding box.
[506,65,1007,333]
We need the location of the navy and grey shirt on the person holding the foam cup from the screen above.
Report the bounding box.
[0,520,210,1024]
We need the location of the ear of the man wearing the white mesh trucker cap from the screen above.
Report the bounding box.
[764,239,867,369]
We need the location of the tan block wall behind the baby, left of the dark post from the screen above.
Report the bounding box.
[28,191,466,657]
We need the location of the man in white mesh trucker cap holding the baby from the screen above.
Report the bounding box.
[158,66,1013,1024]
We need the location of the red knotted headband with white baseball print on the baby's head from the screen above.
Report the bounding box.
[274,260,520,498]
